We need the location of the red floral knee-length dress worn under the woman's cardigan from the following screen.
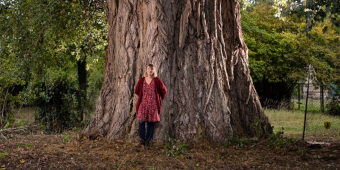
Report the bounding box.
[137,79,161,122]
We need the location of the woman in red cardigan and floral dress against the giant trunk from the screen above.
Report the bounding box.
[135,64,167,146]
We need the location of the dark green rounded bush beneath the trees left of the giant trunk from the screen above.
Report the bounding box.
[29,70,82,132]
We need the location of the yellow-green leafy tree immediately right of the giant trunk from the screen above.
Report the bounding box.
[242,4,308,103]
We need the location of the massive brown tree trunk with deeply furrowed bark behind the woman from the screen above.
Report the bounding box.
[84,0,272,142]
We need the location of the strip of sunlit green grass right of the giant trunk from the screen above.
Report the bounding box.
[264,110,340,141]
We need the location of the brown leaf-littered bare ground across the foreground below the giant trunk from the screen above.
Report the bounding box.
[0,132,340,169]
